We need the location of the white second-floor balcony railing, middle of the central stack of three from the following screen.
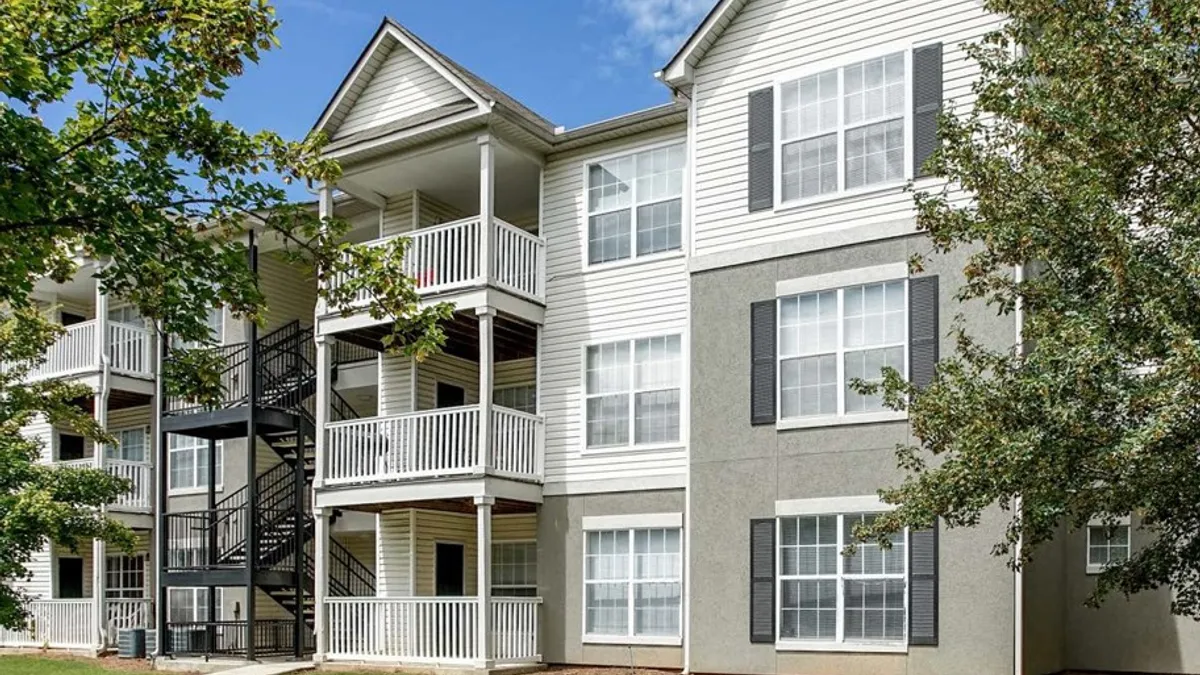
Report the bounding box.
[324,406,541,485]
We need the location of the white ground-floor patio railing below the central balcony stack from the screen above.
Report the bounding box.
[324,597,541,664]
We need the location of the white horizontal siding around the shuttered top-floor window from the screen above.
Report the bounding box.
[691,0,998,257]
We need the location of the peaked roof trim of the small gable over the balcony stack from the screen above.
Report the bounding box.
[313,17,554,138]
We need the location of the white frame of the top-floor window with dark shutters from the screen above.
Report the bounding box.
[772,43,913,211]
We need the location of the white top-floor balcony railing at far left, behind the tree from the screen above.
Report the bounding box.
[15,321,154,381]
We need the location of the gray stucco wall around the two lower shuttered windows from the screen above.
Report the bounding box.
[690,237,1014,675]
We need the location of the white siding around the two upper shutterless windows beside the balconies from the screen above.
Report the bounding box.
[538,125,689,484]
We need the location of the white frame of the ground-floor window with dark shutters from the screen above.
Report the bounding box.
[774,495,912,653]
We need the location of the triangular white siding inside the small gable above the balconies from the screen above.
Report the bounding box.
[334,44,466,138]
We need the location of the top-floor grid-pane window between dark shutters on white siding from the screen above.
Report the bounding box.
[779,52,907,202]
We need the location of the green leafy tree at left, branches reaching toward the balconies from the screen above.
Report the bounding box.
[0,0,449,627]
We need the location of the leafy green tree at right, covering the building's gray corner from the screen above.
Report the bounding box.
[860,0,1200,616]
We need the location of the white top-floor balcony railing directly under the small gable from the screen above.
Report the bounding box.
[332,216,546,305]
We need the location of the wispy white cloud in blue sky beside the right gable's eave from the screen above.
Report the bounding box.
[608,0,716,65]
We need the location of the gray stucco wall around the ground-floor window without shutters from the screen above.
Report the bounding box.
[538,490,688,668]
